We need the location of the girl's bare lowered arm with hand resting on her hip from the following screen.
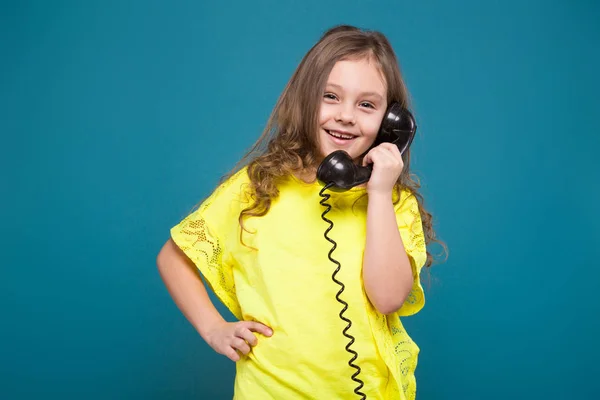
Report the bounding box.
[156,239,273,361]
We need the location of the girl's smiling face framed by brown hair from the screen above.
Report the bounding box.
[317,59,387,159]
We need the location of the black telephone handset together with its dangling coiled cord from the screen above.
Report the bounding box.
[317,103,417,399]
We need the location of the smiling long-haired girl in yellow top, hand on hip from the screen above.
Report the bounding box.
[157,26,437,400]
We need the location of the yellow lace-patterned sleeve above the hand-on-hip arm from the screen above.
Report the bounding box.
[171,167,247,319]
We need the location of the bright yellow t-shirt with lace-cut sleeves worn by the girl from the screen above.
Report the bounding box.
[171,168,426,400]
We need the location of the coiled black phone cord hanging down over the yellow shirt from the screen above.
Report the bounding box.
[319,183,367,400]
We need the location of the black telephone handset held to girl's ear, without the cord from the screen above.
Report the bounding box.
[317,102,417,191]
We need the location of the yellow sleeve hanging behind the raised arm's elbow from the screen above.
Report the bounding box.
[395,190,427,316]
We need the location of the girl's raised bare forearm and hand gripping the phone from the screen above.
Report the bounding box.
[363,143,414,314]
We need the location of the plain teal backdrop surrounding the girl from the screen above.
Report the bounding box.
[0,0,600,400]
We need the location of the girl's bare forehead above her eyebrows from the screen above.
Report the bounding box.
[327,58,387,97]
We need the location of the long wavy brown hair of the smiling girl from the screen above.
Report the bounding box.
[223,25,446,266]
